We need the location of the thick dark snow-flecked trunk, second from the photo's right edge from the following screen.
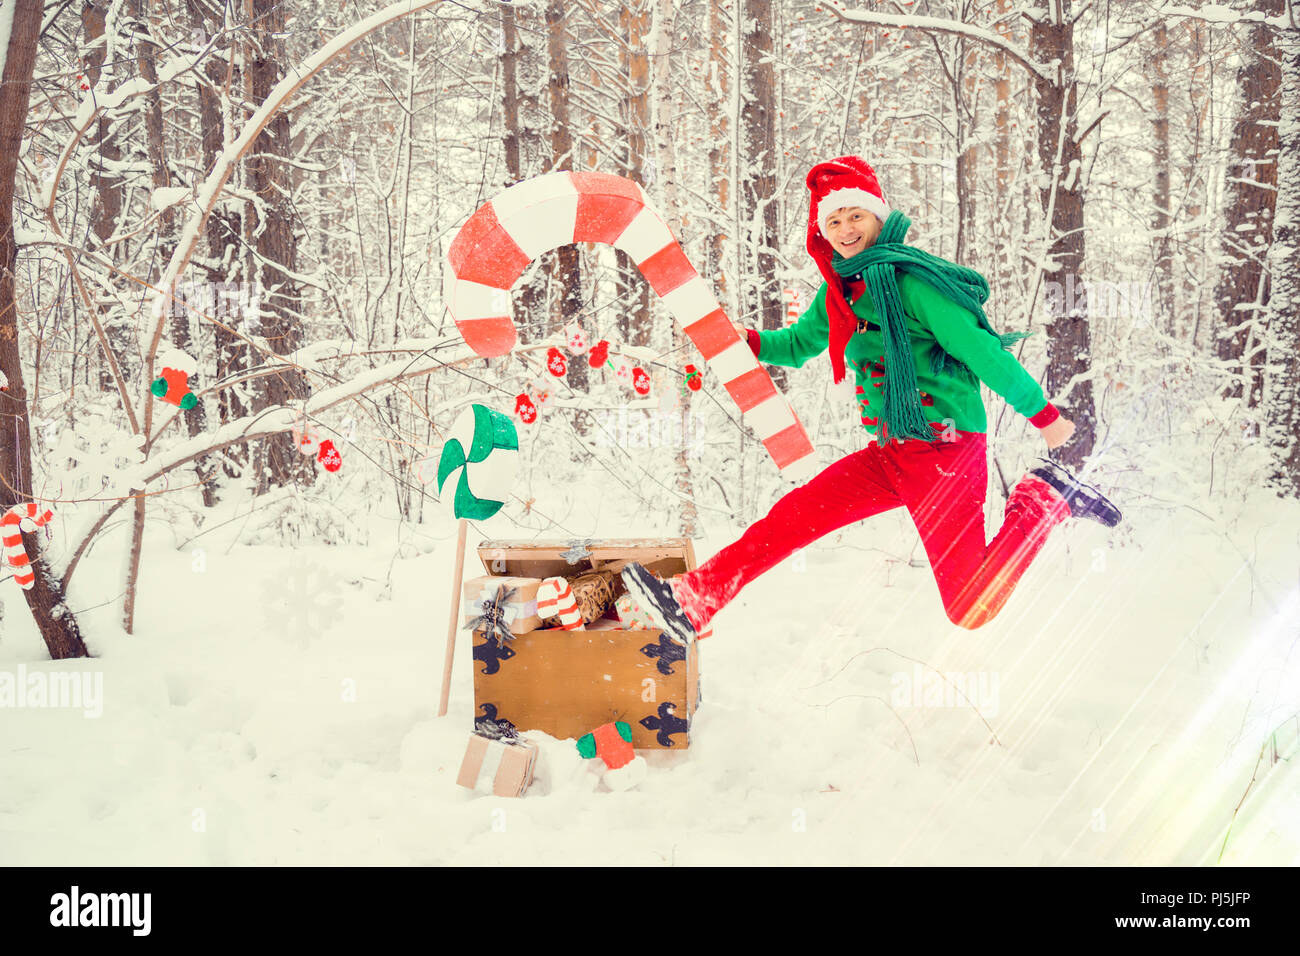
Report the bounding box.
[1214,0,1283,408]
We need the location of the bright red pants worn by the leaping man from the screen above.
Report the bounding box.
[677,432,1070,631]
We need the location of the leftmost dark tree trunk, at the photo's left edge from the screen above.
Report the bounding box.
[0,0,90,659]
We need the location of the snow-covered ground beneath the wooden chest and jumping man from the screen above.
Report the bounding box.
[0,478,1300,865]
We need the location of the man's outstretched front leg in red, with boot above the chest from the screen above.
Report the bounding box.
[623,444,902,644]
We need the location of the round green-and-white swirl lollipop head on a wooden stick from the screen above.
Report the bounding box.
[438,405,519,520]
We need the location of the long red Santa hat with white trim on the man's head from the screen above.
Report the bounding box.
[807,156,889,382]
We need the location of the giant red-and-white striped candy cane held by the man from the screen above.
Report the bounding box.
[443,172,814,479]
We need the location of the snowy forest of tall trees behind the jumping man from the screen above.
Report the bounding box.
[0,0,1300,862]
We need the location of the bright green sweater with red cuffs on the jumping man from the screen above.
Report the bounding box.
[758,273,1048,440]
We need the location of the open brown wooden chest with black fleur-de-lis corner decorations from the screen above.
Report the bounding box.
[473,538,699,749]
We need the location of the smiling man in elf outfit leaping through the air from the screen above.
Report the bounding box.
[623,156,1119,644]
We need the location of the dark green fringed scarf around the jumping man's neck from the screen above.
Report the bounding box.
[831,209,1030,441]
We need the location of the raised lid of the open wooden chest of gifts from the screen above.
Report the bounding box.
[478,537,696,578]
